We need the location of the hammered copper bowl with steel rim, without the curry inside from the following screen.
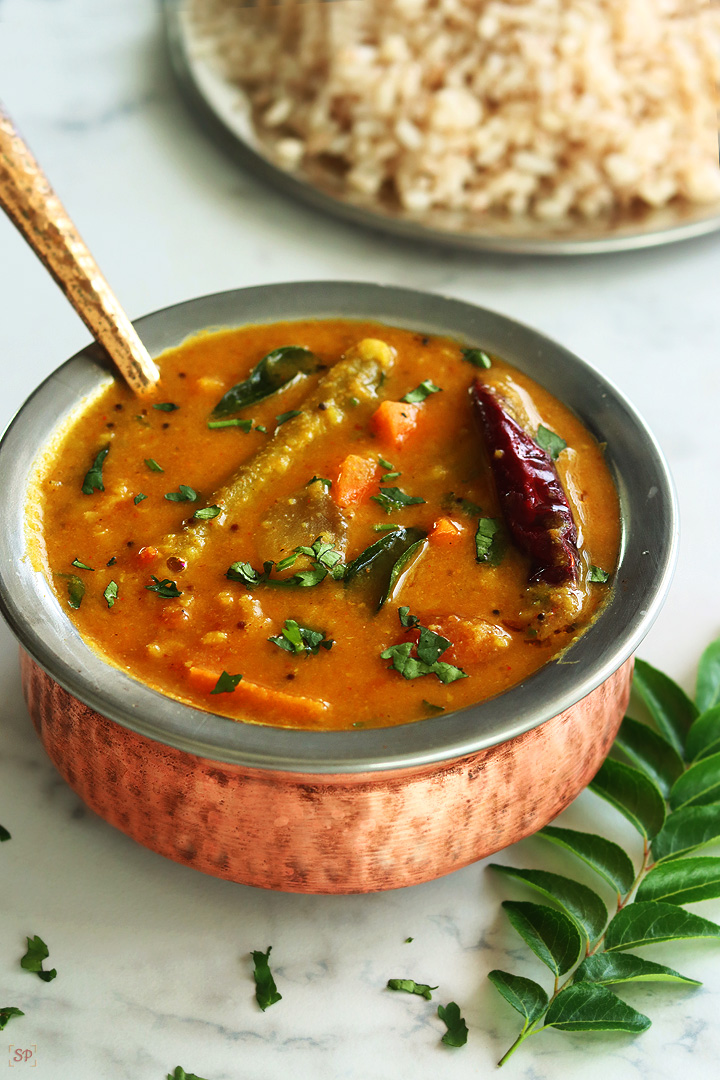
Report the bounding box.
[0,282,677,893]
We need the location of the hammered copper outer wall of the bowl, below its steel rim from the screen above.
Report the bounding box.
[21,652,633,893]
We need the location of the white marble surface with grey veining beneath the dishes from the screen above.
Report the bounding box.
[0,0,720,1080]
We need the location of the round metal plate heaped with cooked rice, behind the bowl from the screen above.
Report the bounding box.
[164,0,720,255]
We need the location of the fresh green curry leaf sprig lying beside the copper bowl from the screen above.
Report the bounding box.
[488,639,720,1065]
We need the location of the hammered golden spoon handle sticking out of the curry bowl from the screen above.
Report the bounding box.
[0,105,160,395]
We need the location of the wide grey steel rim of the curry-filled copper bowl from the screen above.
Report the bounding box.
[0,282,678,773]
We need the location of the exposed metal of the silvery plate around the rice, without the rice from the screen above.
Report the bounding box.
[163,0,720,255]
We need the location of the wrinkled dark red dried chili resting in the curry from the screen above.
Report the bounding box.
[471,379,580,585]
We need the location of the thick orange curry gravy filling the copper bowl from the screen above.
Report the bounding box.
[30,320,620,729]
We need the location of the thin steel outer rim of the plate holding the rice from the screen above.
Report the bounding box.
[162,0,720,256]
